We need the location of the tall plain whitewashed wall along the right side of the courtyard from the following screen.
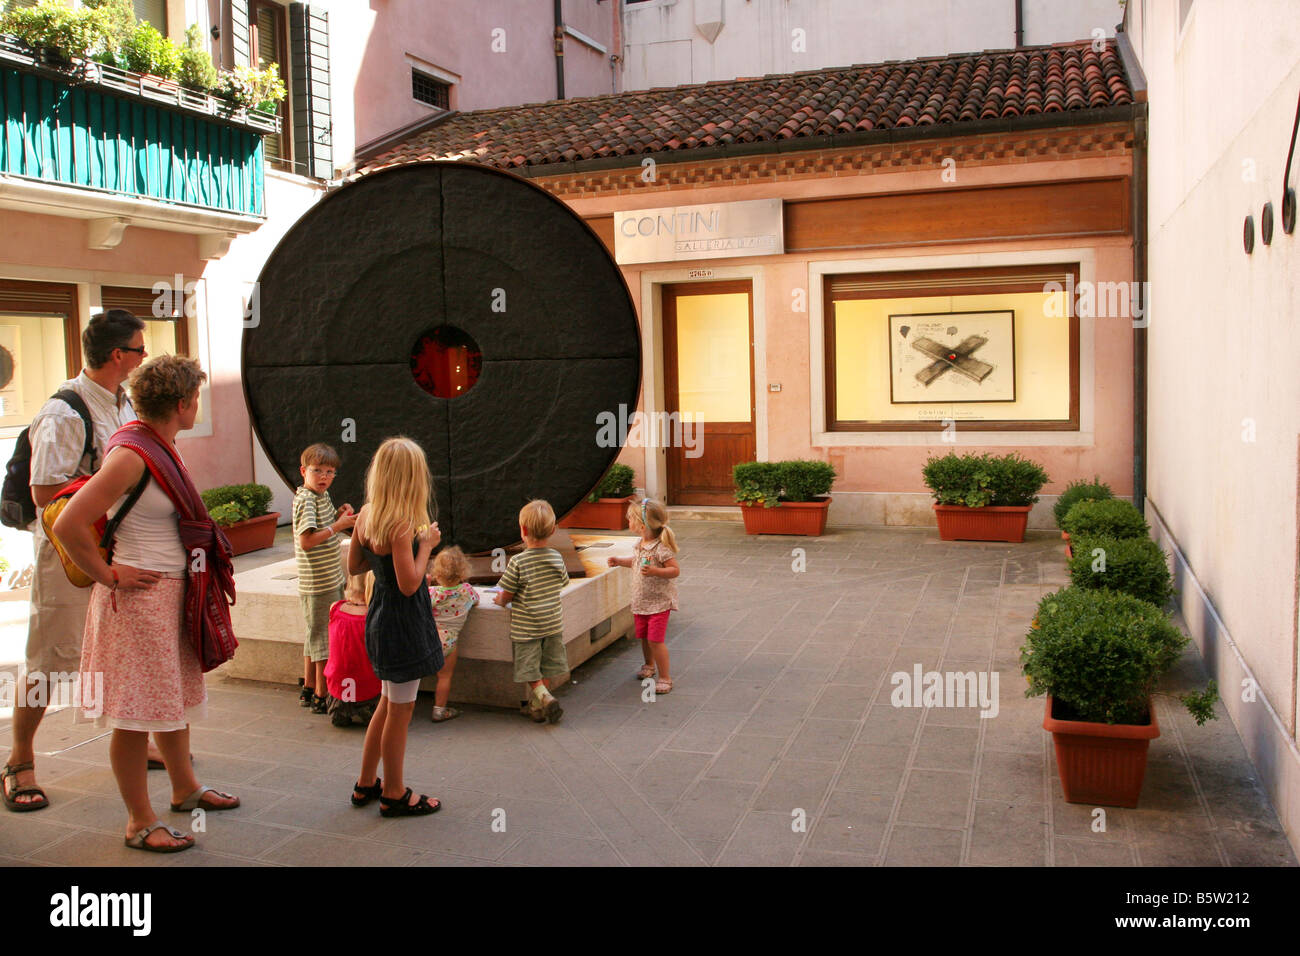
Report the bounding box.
[1130,0,1300,845]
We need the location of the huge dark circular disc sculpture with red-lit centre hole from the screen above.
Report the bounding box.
[243,163,641,551]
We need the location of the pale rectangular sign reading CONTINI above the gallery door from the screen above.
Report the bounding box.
[614,199,785,265]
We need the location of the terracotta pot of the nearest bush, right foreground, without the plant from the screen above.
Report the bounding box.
[1043,696,1160,808]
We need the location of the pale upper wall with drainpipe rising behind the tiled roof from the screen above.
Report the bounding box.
[623,0,1121,90]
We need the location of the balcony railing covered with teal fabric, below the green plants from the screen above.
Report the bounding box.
[0,36,280,216]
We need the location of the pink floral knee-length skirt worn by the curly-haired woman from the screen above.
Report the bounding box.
[78,578,208,732]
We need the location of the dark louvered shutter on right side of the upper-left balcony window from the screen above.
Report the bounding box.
[289,3,334,179]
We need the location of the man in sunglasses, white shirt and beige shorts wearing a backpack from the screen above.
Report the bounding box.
[0,308,161,813]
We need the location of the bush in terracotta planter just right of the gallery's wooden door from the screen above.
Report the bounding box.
[732,459,835,536]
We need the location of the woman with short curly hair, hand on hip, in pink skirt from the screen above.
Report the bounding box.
[55,355,239,853]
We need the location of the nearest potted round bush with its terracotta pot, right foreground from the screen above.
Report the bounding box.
[1021,587,1218,808]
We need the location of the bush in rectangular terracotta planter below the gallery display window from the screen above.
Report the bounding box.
[920,451,1049,544]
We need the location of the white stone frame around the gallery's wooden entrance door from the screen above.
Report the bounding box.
[628,261,768,501]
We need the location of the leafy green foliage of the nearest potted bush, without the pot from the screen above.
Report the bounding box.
[1021,588,1218,724]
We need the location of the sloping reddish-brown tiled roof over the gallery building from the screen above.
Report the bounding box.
[361,42,1134,172]
